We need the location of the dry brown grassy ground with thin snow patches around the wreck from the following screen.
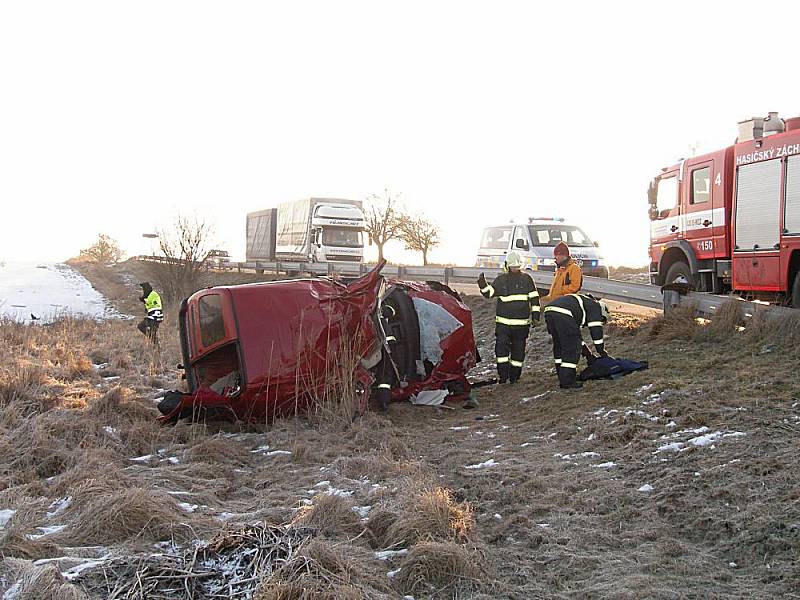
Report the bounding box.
[0,264,800,600]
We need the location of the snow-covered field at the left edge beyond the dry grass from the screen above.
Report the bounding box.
[0,262,122,323]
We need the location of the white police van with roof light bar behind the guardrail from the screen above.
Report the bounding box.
[476,218,608,277]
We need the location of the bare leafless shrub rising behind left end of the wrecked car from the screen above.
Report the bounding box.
[149,216,213,302]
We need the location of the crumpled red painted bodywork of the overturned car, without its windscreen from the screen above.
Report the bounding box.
[162,264,477,421]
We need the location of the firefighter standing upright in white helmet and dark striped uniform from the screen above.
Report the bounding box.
[478,251,540,383]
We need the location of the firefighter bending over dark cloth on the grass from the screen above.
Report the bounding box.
[544,294,608,389]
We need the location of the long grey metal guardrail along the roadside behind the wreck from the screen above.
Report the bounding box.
[135,256,800,318]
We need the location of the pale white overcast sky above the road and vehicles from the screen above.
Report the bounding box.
[0,0,800,265]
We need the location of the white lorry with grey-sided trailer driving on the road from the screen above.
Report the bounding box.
[246,198,364,263]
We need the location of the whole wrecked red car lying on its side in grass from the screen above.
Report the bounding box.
[159,263,479,421]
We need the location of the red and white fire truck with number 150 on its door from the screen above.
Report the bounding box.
[648,113,800,307]
